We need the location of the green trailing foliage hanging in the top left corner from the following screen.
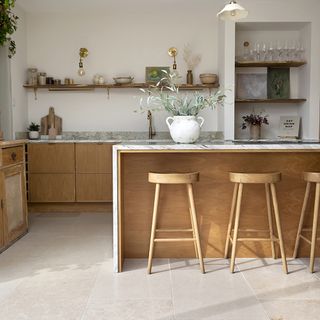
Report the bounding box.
[0,0,19,58]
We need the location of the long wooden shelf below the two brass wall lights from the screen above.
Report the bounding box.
[23,83,219,100]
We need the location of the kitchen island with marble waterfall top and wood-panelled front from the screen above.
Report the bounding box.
[113,141,320,272]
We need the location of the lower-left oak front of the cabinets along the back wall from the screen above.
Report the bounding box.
[29,173,75,202]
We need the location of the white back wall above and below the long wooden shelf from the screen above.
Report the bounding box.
[27,0,219,131]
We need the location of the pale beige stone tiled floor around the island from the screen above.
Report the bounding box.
[0,213,320,320]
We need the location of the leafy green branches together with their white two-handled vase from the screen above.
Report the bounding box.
[140,70,225,143]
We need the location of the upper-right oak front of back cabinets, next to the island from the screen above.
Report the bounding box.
[76,143,112,173]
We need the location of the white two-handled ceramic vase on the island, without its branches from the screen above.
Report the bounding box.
[166,116,204,143]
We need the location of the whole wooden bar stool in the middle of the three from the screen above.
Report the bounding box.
[225,172,288,273]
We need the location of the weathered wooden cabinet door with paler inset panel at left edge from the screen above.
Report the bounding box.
[1,165,28,244]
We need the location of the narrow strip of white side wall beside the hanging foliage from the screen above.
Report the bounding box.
[10,6,28,132]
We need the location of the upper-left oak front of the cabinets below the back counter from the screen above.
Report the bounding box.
[28,143,75,173]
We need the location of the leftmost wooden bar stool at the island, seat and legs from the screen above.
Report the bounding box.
[148,172,205,274]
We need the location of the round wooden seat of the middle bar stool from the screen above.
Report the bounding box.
[229,172,281,183]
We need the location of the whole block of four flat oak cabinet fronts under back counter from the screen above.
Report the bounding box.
[28,142,112,203]
